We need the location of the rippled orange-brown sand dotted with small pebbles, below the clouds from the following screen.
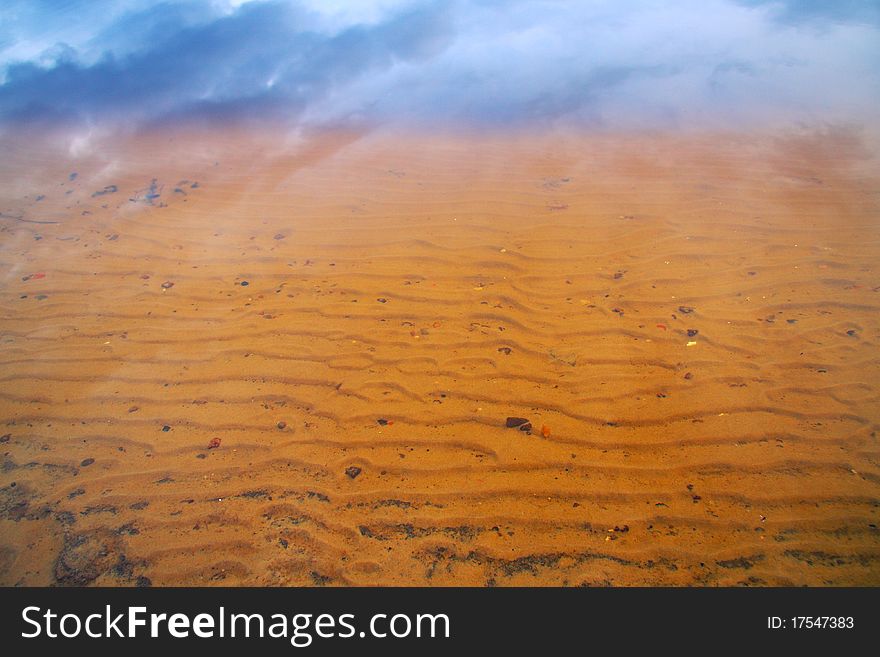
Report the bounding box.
[0,129,880,586]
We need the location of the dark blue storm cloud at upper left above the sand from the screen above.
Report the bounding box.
[0,3,448,124]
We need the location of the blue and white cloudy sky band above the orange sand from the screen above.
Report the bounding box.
[0,0,880,128]
